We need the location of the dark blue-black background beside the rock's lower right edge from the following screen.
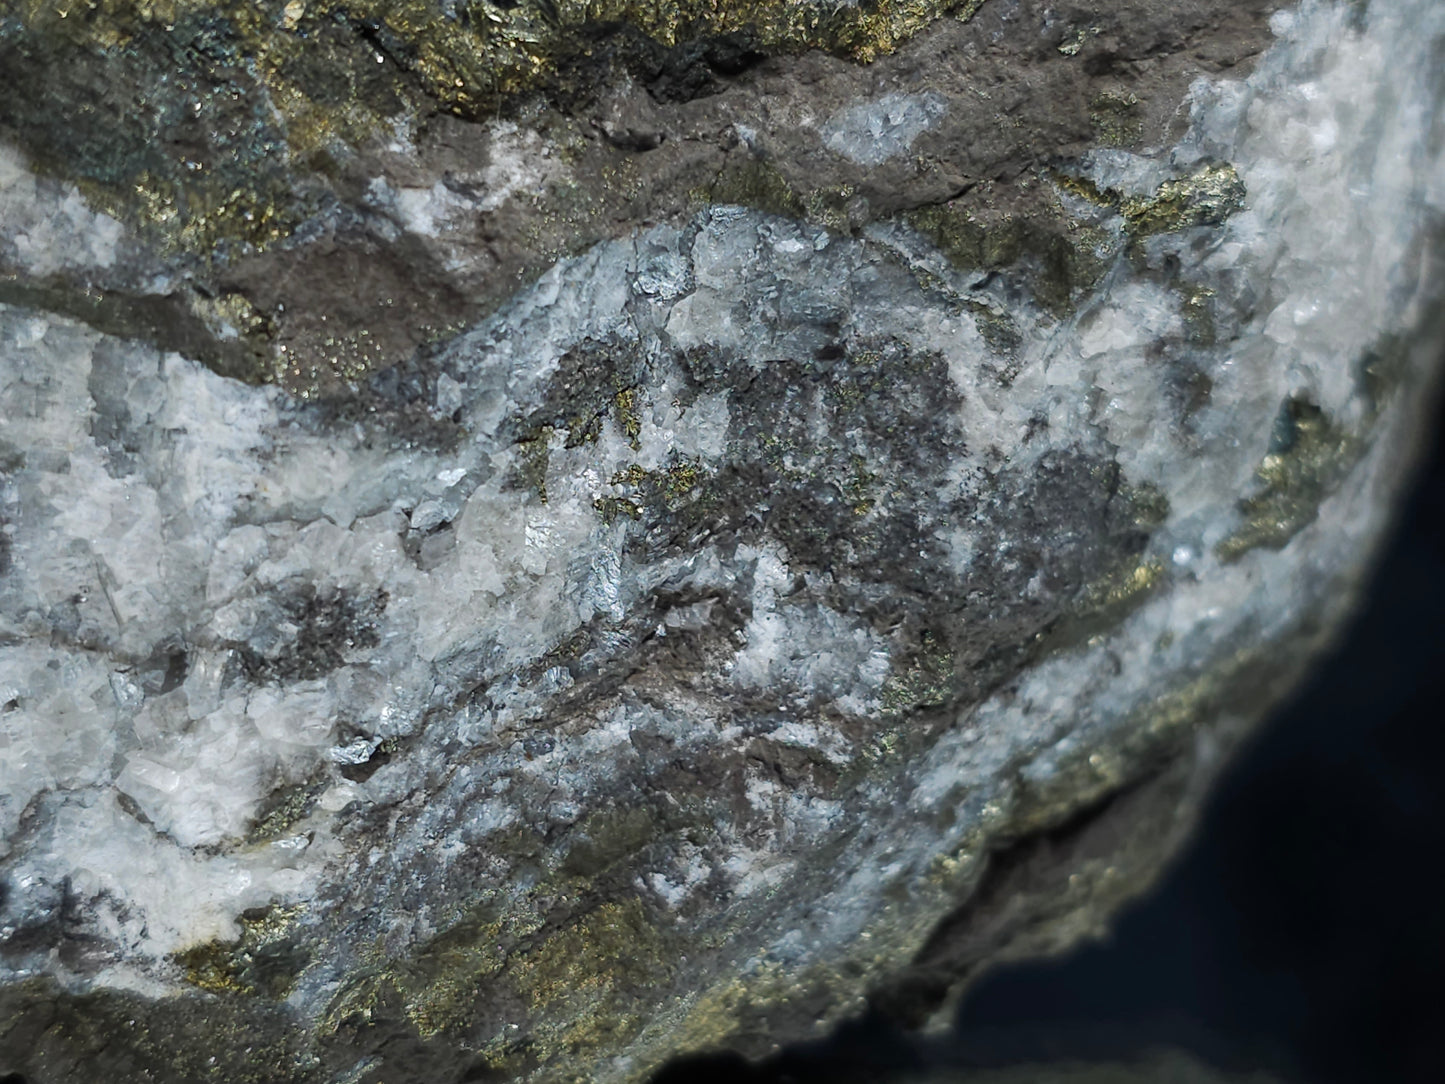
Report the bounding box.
[657,393,1445,1084]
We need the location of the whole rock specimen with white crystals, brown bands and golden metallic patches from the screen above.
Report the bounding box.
[0,0,1445,1084]
